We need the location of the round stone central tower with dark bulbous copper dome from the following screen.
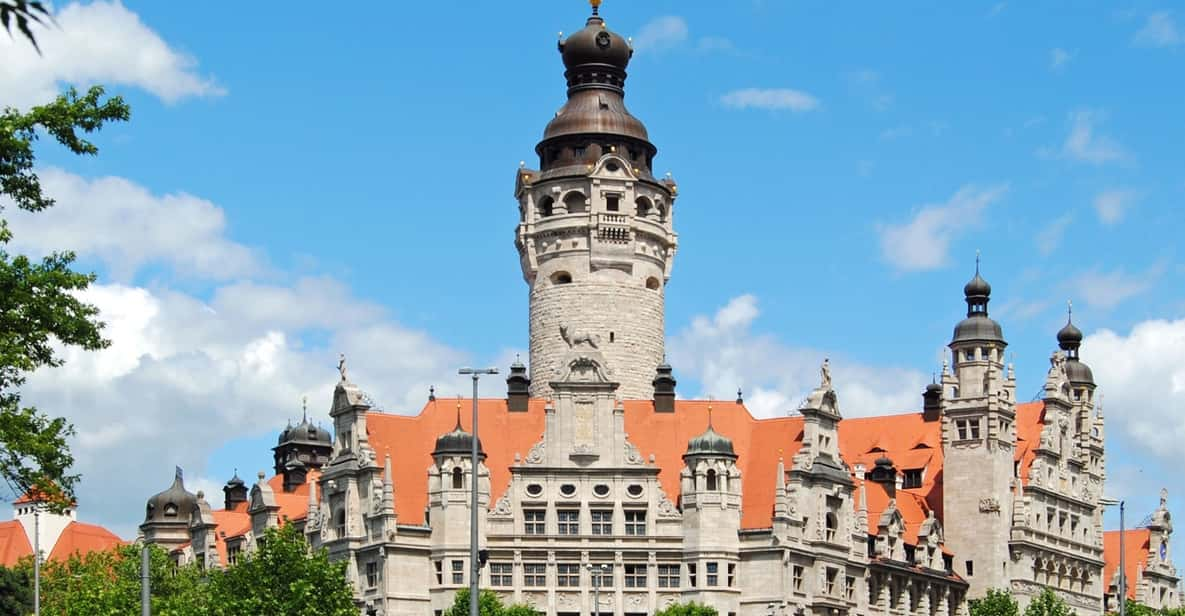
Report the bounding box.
[514,2,678,399]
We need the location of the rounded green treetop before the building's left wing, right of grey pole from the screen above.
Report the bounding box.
[207,524,358,616]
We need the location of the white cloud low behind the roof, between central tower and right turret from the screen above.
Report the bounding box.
[667,295,925,417]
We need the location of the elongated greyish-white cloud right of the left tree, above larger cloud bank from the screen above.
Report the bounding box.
[0,168,262,281]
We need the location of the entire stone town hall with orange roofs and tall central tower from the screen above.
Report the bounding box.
[141,4,1178,616]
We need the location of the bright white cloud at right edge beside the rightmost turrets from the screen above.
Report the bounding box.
[1082,319,1185,462]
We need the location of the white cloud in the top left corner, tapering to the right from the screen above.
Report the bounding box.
[0,1,225,108]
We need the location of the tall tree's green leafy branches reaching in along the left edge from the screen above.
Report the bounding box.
[0,85,130,511]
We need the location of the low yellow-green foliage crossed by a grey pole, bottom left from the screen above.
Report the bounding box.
[34,545,205,616]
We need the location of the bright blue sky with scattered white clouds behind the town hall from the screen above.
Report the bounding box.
[0,0,1185,534]
